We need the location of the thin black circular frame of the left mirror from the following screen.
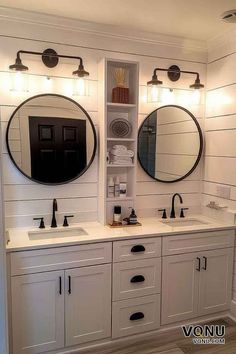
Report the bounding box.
[6,93,97,186]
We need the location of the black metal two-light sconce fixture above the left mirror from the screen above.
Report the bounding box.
[9,48,89,78]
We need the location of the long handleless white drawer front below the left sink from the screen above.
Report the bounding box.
[11,242,112,275]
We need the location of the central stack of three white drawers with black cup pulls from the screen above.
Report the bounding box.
[112,237,161,338]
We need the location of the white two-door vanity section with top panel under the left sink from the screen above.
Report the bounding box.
[11,243,112,354]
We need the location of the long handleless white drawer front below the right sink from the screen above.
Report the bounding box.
[162,230,234,256]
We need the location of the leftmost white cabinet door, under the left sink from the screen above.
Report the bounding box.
[11,271,64,354]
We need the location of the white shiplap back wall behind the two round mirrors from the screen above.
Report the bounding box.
[0,9,206,227]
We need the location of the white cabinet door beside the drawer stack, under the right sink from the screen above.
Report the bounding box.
[161,253,200,324]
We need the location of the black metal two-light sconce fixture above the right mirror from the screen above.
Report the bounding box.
[147,65,204,90]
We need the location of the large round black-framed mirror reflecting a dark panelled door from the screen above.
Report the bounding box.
[6,94,97,185]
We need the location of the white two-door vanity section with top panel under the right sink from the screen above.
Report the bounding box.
[161,231,234,324]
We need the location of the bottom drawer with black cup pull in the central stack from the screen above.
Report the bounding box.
[112,294,160,338]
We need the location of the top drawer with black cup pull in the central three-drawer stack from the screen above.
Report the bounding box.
[113,237,161,262]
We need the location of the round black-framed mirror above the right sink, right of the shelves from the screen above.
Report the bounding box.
[138,105,203,183]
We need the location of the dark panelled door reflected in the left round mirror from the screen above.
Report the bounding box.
[29,116,87,183]
